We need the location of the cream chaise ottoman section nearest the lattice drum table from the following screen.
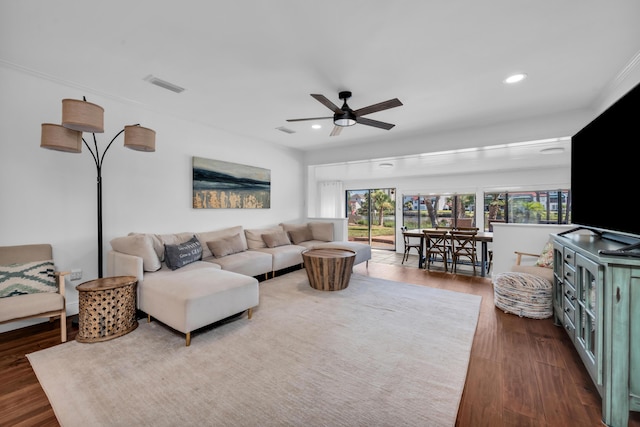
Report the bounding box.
[138,262,259,346]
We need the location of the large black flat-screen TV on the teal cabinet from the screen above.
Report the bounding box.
[571,84,640,242]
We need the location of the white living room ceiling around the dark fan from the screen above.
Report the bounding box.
[0,0,640,159]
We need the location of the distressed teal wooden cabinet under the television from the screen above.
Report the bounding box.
[553,234,640,427]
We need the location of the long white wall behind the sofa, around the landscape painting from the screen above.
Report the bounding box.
[0,66,305,331]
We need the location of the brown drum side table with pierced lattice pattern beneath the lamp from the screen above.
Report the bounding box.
[76,276,138,342]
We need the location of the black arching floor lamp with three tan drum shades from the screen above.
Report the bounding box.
[40,97,156,278]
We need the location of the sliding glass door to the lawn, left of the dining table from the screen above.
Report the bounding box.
[346,188,396,251]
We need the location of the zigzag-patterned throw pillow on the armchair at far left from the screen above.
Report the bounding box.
[0,260,58,298]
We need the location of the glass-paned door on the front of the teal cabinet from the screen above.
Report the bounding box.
[575,254,603,385]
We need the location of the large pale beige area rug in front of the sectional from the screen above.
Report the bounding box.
[27,270,481,426]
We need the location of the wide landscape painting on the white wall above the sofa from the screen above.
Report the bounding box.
[193,156,271,209]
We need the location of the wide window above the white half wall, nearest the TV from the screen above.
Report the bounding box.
[484,190,569,231]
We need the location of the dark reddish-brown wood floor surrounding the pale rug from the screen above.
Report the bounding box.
[0,262,640,427]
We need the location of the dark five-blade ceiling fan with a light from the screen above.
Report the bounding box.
[287,91,402,136]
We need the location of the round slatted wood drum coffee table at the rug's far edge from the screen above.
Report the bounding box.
[302,248,356,291]
